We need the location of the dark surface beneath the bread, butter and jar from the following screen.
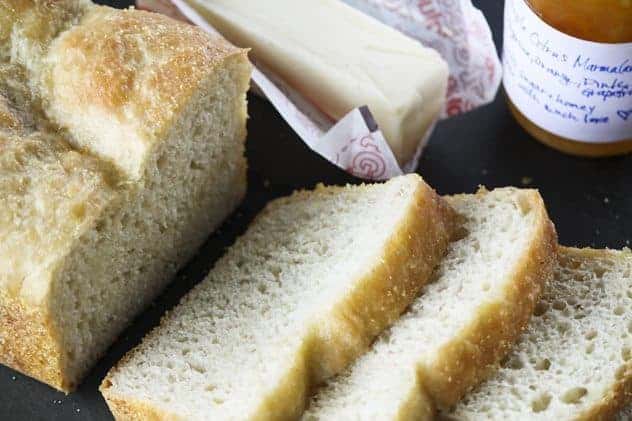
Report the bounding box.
[0,0,632,420]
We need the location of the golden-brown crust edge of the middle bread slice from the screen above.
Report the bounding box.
[423,191,557,408]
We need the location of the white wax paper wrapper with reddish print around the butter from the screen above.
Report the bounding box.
[137,0,502,180]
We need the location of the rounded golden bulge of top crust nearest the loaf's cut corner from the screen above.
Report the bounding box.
[44,7,244,174]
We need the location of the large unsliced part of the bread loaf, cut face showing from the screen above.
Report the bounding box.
[0,0,250,391]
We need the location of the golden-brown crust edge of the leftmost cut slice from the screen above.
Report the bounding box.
[312,176,456,384]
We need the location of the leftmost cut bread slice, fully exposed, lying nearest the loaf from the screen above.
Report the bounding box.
[101,175,453,420]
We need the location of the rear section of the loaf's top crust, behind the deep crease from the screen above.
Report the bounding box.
[0,0,247,179]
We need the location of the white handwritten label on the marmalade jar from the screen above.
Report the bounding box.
[503,0,632,143]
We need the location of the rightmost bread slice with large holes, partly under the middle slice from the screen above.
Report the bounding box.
[448,248,632,421]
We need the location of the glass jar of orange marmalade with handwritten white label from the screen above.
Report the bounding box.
[503,0,632,157]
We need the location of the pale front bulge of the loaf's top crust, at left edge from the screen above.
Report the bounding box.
[0,130,115,300]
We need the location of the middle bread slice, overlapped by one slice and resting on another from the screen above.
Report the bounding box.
[303,188,556,421]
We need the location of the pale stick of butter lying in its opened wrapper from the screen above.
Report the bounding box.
[187,0,448,165]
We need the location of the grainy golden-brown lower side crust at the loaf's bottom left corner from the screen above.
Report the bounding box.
[0,291,65,392]
